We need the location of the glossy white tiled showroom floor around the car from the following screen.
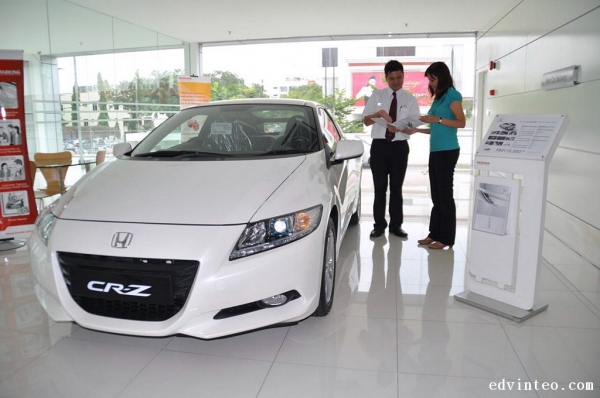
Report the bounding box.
[0,170,600,398]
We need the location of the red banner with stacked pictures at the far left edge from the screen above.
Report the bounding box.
[0,50,37,240]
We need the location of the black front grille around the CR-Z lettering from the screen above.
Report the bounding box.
[58,252,200,322]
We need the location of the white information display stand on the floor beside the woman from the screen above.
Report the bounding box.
[454,115,568,322]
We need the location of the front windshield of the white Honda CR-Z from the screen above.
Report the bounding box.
[131,103,322,160]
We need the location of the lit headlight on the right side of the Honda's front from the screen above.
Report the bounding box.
[229,205,323,260]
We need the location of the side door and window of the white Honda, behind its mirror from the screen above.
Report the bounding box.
[318,108,361,227]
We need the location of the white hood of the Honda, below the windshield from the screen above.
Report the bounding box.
[57,156,306,225]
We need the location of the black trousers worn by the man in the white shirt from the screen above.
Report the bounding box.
[370,139,410,230]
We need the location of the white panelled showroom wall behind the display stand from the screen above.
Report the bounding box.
[476,0,600,267]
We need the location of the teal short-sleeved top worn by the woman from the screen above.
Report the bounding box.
[427,87,462,152]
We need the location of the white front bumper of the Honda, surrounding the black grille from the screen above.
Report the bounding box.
[30,220,324,339]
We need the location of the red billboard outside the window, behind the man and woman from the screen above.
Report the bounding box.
[352,71,433,106]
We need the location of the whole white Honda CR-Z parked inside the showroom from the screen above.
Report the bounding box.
[30,99,363,339]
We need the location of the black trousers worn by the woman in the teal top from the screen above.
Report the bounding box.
[429,149,460,245]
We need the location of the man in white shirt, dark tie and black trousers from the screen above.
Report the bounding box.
[363,60,419,238]
